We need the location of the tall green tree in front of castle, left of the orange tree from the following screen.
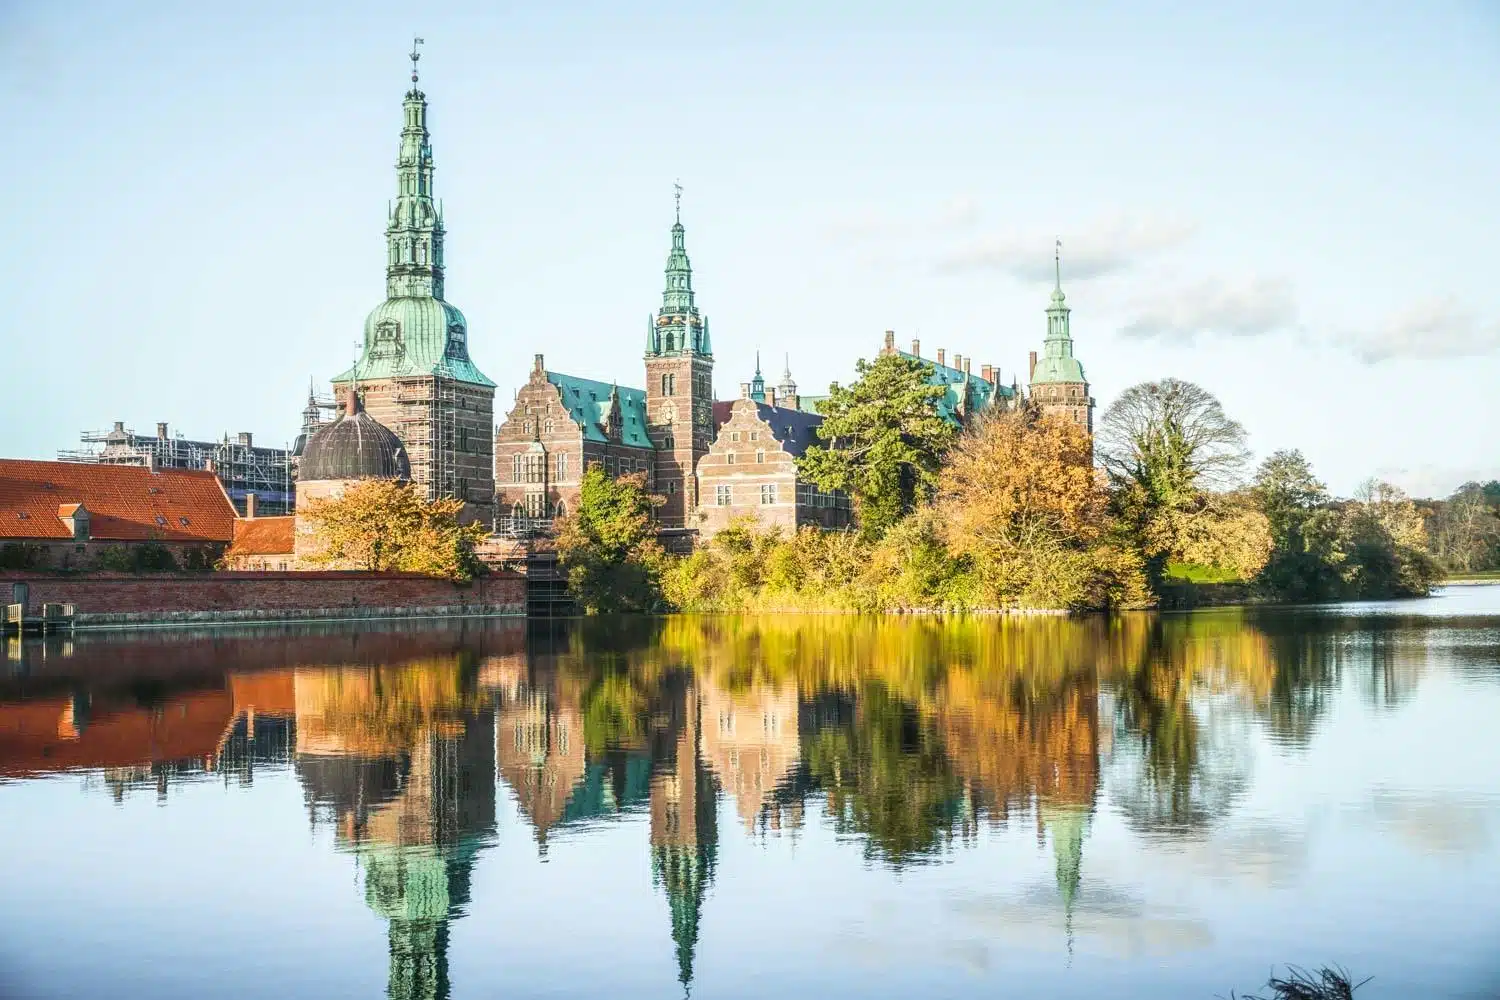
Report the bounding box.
[798,354,956,538]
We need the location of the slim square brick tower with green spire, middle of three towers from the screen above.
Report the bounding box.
[645,184,714,528]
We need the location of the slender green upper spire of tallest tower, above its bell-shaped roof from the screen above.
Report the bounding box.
[386,37,443,298]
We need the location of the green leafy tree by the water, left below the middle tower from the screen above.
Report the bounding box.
[558,465,666,615]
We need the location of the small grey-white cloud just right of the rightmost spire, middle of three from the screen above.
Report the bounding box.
[1121,277,1298,342]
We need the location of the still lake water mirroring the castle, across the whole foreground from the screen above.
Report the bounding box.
[0,586,1500,1000]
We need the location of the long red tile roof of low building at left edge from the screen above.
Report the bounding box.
[0,459,234,541]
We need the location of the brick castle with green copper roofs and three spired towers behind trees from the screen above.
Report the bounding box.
[305,49,1094,550]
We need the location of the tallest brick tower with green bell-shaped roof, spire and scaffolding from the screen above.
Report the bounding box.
[333,39,495,520]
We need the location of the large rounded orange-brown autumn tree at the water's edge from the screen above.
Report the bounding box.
[936,409,1148,607]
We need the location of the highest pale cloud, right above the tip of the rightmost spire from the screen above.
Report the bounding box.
[938,216,1197,282]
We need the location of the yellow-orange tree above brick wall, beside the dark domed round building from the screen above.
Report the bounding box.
[302,480,485,580]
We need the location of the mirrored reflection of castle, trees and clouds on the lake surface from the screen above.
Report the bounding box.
[0,599,1497,997]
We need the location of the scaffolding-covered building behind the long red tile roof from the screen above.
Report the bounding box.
[57,420,294,514]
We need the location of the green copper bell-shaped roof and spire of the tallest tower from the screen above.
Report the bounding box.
[333,73,495,387]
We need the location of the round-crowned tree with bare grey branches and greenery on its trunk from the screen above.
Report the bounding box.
[1095,378,1250,582]
